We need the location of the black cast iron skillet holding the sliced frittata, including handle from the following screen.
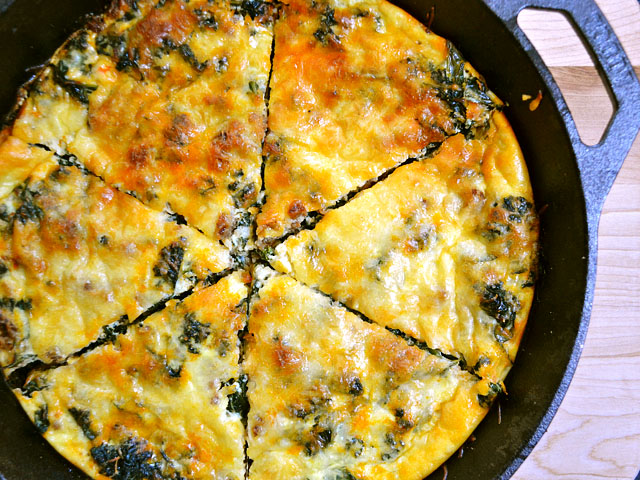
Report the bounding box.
[0,0,640,480]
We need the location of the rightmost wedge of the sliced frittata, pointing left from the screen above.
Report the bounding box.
[273,114,537,382]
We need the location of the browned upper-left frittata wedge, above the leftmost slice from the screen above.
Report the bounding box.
[13,0,272,247]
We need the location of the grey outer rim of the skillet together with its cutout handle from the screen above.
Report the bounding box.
[484,0,640,478]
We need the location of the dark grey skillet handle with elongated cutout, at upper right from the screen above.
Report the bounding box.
[485,0,640,219]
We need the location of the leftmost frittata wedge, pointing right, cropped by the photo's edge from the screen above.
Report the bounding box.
[0,163,231,368]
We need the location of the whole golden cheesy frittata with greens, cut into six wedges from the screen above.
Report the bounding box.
[0,0,537,480]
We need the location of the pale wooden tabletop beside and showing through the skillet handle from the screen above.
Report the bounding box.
[514,0,640,480]
